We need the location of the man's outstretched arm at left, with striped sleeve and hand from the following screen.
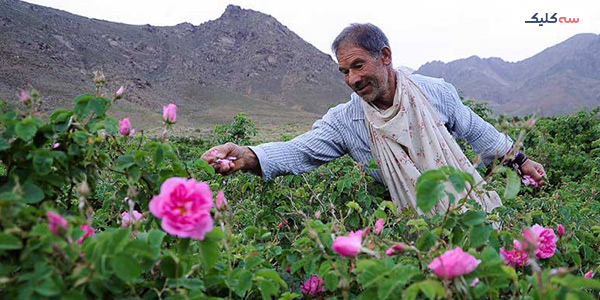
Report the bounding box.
[202,110,347,180]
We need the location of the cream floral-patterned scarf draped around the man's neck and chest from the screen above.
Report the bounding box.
[362,70,502,214]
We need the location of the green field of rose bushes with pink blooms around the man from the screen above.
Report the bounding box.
[0,81,600,299]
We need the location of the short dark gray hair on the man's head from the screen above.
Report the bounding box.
[331,23,390,58]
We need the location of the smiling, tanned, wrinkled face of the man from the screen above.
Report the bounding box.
[337,43,389,102]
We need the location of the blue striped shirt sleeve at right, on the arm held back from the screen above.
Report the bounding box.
[444,82,513,165]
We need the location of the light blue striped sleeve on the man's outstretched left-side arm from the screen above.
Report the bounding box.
[250,110,347,181]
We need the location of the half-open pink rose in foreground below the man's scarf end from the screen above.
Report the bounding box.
[429,247,481,279]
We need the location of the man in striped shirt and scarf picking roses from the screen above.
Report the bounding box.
[202,24,544,213]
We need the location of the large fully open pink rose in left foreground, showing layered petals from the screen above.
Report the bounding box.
[149,177,213,240]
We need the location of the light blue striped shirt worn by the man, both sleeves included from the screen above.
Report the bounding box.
[250,74,513,182]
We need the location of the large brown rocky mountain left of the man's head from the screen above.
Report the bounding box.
[0,0,351,134]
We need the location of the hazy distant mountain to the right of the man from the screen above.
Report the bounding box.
[415,33,600,115]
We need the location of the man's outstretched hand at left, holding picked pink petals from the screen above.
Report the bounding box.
[201,143,261,176]
